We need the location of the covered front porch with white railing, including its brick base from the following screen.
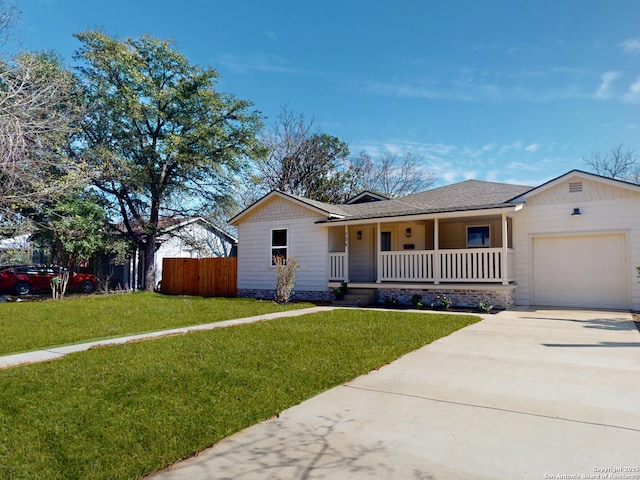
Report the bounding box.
[328,210,516,308]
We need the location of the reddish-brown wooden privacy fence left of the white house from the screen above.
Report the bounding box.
[160,257,238,297]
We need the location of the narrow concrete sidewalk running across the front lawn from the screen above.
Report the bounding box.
[0,307,331,369]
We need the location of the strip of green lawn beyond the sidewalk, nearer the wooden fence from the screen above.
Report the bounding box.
[0,292,313,355]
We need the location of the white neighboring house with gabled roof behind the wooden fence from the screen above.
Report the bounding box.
[113,217,237,290]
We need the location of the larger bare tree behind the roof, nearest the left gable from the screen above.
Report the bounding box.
[245,107,351,203]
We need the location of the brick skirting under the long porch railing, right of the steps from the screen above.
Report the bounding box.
[378,285,516,310]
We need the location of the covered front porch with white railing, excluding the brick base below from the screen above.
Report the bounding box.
[328,210,515,285]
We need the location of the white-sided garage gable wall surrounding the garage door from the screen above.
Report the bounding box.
[514,178,640,310]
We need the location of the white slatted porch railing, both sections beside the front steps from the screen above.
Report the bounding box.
[329,248,515,282]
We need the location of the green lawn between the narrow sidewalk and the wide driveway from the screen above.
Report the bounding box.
[0,309,479,479]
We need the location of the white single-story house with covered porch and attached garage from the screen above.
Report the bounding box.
[230,170,640,310]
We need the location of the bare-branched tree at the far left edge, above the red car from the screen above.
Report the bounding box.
[0,1,84,221]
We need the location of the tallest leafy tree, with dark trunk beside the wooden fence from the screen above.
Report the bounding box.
[75,31,262,290]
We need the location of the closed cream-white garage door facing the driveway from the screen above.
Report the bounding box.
[533,234,629,308]
